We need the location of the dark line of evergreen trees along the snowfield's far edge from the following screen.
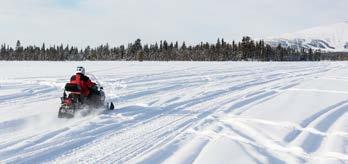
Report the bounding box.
[0,36,327,61]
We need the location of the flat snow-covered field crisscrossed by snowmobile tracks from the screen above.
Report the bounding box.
[0,61,348,164]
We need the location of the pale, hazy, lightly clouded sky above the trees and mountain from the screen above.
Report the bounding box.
[0,0,348,47]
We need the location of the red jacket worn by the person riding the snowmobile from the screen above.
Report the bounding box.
[70,73,95,97]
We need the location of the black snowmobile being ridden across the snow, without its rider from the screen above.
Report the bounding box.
[58,83,114,118]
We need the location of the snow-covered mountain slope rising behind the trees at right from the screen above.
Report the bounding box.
[265,21,348,52]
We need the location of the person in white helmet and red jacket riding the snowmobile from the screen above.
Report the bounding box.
[70,66,99,98]
